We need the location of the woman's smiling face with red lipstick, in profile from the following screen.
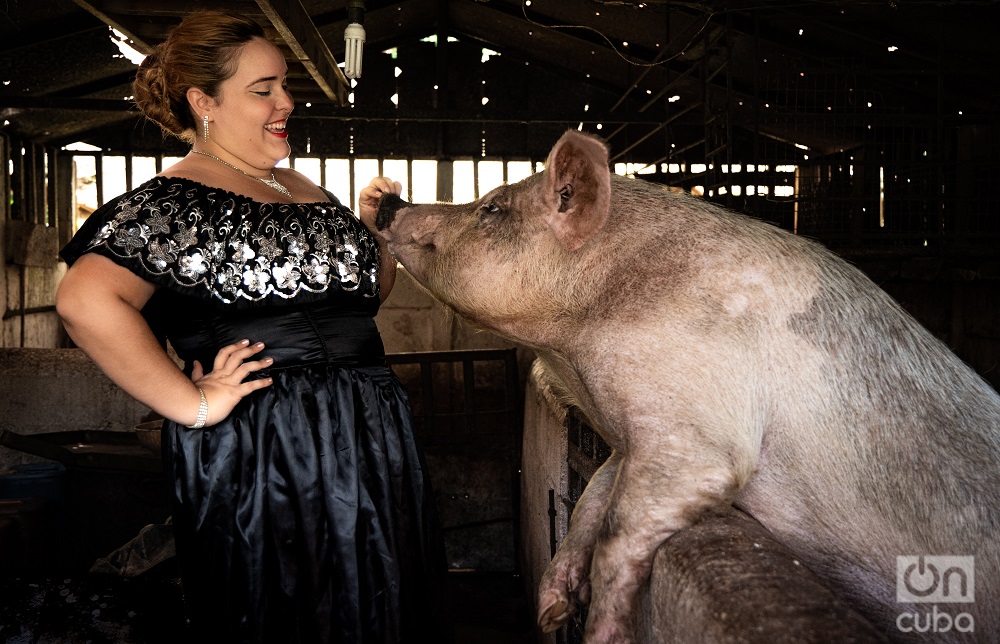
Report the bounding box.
[209,38,294,169]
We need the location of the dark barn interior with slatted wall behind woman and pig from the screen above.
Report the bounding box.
[0,0,1000,642]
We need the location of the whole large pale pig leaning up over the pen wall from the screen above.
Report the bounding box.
[377,132,1000,642]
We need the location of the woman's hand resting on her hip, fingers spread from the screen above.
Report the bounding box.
[187,340,274,427]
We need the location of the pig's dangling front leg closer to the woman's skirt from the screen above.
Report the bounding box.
[538,452,621,633]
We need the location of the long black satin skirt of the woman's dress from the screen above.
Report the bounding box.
[164,354,451,644]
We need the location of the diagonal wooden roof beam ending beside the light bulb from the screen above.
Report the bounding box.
[257,0,350,105]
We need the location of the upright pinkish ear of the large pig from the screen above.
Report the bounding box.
[544,130,611,251]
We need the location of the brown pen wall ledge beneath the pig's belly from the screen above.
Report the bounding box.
[638,508,887,644]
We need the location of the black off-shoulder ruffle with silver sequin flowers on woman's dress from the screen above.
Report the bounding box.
[86,177,379,304]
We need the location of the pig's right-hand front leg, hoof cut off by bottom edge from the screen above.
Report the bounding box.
[584,441,737,644]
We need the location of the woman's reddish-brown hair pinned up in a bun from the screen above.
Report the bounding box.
[132,11,264,142]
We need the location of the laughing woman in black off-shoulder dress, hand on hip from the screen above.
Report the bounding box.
[57,12,444,643]
